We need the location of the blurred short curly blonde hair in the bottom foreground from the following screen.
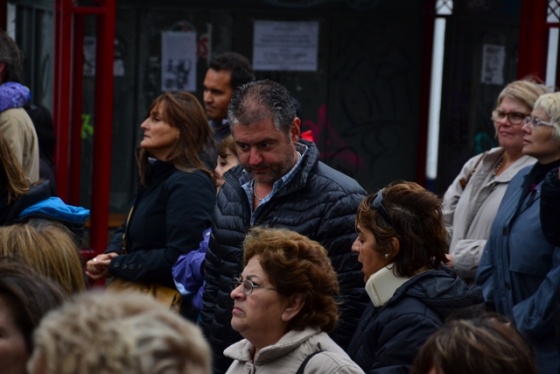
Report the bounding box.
[28,290,211,374]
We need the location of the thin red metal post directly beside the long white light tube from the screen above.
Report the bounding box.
[416,0,436,187]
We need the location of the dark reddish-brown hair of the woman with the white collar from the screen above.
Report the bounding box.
[356,182,448,277]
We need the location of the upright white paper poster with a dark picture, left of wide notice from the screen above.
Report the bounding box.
[161,31,196,92]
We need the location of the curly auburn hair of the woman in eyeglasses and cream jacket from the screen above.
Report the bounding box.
[244,227,339,332]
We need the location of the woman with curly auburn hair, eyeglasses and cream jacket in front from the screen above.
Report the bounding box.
[224,227,363,374]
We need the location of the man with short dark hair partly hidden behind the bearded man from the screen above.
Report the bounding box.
[203,52,255,143]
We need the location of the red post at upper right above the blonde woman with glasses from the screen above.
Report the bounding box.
[517,0,548,81]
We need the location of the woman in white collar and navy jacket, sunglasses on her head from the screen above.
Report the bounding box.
[348,182,483,373]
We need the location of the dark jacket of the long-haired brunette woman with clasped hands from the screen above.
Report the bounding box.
[105,161,216,288]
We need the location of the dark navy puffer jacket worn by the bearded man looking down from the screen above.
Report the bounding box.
[199,140,368,373]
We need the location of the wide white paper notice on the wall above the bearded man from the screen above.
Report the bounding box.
[253,21,319,71]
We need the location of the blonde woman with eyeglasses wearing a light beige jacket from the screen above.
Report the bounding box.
[443,80,547,284]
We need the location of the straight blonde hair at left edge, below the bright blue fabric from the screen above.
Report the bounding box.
[0,223,85,294]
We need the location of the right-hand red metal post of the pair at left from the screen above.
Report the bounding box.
[90,0,116,252]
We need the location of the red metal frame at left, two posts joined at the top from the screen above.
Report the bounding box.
[53,0,116,260]
